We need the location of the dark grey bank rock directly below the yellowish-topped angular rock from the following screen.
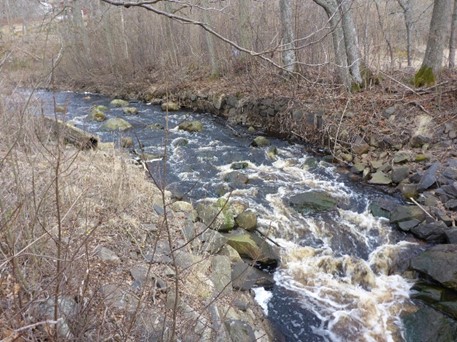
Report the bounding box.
[231,261,274,291]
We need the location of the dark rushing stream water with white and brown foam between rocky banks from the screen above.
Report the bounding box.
[36,91,414,341]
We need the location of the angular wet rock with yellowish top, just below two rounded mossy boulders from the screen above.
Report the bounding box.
[224,229,279,266]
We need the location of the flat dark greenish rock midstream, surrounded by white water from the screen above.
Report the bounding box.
[288,190,338,214]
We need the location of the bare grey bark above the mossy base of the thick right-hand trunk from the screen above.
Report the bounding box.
[421,0,451,74]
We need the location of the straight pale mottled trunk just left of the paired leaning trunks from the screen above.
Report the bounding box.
[279,0,297,72]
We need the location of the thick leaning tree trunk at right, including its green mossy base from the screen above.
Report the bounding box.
[414,0,451,87]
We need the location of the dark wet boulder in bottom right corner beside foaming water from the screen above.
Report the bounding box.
[403,306,457,342]
